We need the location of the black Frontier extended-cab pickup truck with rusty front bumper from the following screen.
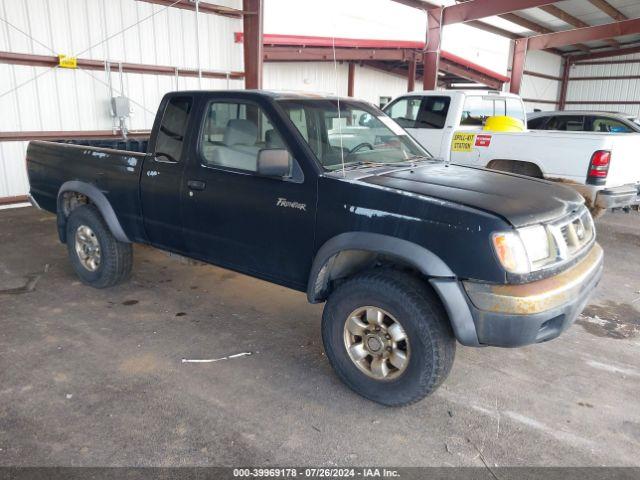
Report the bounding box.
[27,91,603,405]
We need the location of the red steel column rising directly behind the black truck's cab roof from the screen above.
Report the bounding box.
[242,0,264,89]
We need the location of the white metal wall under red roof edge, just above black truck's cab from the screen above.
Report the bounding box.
[264,62,407,105]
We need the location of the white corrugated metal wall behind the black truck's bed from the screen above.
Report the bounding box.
[0,0,243,197]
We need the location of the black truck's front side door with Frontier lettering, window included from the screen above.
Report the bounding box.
[183,97,316,288]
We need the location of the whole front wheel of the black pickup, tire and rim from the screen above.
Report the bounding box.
[322,269,456,406]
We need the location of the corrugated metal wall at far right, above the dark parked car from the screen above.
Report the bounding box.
[567,54,640,115]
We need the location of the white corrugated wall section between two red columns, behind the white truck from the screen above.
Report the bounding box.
[520,51,562,111]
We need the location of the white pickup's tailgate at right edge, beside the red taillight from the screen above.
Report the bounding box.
[606,133,640,187]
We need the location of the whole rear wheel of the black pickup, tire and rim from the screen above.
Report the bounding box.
[67,205,133,288]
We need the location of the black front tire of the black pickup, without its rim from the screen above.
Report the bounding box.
[322,269,456,407]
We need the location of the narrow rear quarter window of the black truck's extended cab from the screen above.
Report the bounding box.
[155,97,193,162]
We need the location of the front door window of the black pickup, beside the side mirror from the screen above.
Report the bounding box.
[200,102,286,172]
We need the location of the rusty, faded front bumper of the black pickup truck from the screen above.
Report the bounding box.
[463,243,603,347]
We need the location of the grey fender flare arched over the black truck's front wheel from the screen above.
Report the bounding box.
[307,232,480,347]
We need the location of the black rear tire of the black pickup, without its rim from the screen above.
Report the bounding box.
[67,205,133,288]
